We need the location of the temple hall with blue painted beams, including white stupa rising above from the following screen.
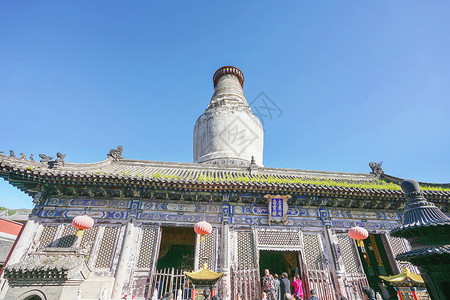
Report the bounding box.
[0,66,450,300]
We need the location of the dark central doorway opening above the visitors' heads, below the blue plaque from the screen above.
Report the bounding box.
[259,250,300,279]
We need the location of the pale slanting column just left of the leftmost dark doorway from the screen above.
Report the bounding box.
[111,219,136,299]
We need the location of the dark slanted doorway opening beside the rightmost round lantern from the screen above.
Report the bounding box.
[357,234,397,298]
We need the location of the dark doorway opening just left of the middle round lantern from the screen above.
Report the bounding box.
[156,227,195,271]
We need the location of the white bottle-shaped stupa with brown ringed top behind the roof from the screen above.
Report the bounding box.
[194,66,264,166]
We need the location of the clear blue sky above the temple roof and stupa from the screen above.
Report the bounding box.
[0,1,450,208]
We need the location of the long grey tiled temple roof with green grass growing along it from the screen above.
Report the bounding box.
[0,153,450,200]
